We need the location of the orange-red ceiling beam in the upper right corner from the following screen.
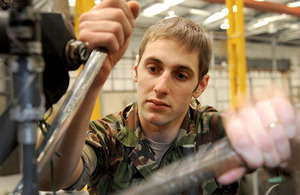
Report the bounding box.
[203,0,300,18]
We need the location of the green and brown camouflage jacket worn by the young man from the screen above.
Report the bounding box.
[70,101,238,195]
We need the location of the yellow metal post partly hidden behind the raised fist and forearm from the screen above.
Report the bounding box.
[74,0,101,120]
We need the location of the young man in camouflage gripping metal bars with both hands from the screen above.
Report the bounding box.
[41,0,299,194]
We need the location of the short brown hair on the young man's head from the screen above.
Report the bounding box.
[139,17,212,82]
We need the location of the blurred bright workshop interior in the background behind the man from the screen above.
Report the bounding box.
[0,0,300,194]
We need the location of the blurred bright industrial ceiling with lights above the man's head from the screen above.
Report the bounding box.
[27,0,300,45]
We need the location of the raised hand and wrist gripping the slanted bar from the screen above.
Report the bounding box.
[79,0,139,85]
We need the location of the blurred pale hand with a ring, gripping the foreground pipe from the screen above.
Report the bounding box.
[218,95,300,184]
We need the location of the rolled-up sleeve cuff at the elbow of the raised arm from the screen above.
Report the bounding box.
[65,144,97,191]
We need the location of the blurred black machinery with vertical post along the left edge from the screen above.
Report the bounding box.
[0,0,89,195]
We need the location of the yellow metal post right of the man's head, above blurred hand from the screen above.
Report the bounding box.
[226,0,247,110]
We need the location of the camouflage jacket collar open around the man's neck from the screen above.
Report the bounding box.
[117,103,199,178]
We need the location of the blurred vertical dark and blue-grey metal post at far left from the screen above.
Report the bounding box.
[7,0,45,195]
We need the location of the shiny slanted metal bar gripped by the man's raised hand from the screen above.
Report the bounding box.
[37,50,107,178]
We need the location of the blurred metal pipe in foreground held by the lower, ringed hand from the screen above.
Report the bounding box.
[121,138,245,195]
